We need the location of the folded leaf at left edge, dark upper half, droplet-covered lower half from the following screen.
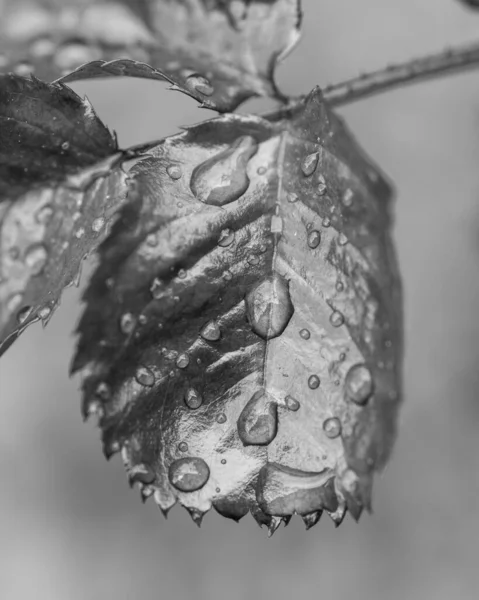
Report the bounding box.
[0,75,133,353]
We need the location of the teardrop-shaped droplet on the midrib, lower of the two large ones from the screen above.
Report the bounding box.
[238,390,278,446]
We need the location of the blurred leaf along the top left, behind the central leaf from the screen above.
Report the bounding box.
[0,0,301,112]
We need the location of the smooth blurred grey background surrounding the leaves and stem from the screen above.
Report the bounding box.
[0,0,479,600]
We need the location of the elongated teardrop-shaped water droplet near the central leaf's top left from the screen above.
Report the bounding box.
[190,135,258,206]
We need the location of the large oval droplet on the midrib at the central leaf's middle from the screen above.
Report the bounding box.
[245,273,294,340]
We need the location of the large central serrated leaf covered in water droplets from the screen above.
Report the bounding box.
[73,89,402,532]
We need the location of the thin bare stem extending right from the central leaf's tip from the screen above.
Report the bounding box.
[323,43,479,106]
